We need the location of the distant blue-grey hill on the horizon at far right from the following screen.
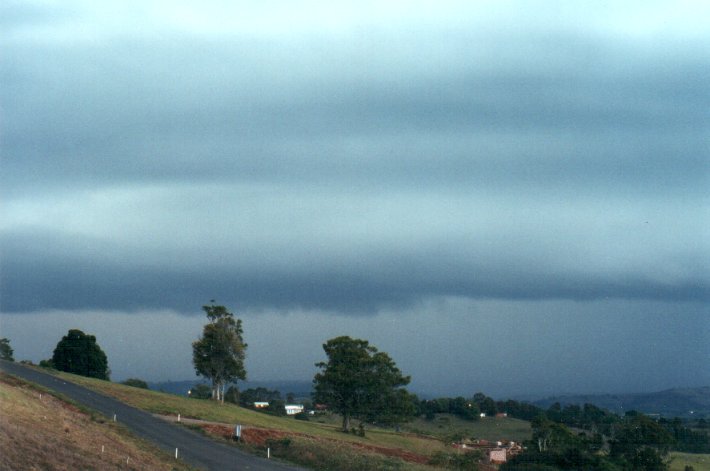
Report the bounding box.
[533,386,710,417]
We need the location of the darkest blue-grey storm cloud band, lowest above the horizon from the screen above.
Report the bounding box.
[0,227,710,313]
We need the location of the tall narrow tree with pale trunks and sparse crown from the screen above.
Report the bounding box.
[192,304,247,402]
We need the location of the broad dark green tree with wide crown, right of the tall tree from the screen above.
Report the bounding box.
[313,336,414,432]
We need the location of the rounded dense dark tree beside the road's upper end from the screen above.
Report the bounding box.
[52,329,109,379]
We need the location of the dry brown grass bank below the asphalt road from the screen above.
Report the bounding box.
[0,373,191,471]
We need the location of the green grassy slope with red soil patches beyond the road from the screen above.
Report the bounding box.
[34,373,529,470]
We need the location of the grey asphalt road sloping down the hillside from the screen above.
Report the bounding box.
[0,360,300,471]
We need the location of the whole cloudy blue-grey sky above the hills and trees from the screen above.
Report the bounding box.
[0,0,710,397]
